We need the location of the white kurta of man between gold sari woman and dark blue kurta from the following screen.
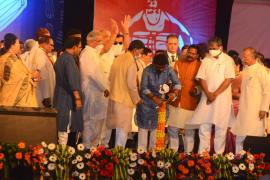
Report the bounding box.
[31,48,55,107]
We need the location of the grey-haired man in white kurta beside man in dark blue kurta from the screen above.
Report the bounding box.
[80,31,108,148]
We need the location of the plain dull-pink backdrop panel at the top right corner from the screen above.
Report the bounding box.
[227,0,270,58]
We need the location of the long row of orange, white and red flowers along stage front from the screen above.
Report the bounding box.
[0,142,270,180]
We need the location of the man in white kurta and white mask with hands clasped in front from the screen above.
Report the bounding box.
[186,37,235,154]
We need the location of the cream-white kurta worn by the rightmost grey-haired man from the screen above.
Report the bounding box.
[232,63,270,136]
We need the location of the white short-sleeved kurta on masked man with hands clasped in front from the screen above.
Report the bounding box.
[186,53,235,129]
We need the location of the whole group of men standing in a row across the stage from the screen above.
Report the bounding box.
[1,22,270,154]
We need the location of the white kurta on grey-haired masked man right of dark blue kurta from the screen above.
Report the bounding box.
[80,46,109,120]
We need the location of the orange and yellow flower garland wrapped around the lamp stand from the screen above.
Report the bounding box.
[156,102,166,151]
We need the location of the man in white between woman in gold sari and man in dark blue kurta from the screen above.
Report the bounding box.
[30,36,55,107]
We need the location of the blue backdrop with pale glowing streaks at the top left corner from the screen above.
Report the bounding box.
[0,0,64,47]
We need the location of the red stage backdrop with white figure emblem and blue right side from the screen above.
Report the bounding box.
[94,0,216,50]
